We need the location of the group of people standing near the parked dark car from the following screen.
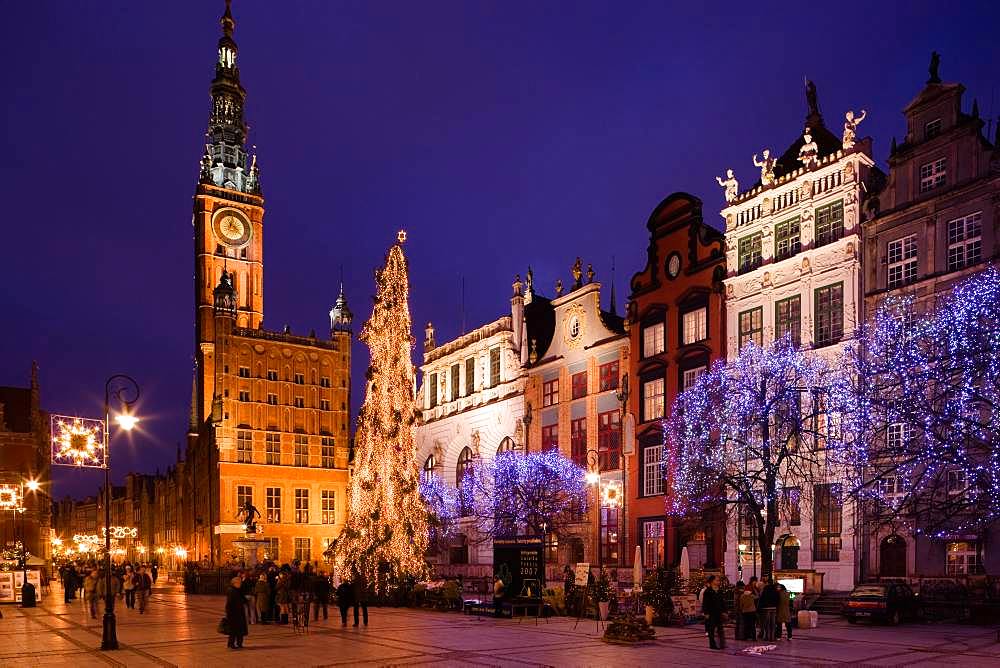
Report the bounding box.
[700,575,792,649]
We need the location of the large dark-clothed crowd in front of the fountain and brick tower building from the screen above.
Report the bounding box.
[225,561,368,649]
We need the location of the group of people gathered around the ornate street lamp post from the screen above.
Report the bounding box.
[59,561,159,619]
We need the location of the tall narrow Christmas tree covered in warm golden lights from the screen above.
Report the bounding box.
[334,232,428,593]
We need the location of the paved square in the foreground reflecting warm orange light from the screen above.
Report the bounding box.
[0,586,1000,668]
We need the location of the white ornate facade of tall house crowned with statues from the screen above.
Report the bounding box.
[721,134,874,591]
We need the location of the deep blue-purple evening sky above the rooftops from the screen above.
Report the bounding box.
[0,0,1000,496]
